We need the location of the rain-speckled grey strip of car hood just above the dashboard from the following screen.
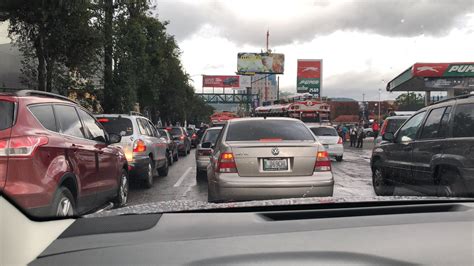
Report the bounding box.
[84,196,462,217]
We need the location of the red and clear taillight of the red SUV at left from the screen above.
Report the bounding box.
[0,136,49,157]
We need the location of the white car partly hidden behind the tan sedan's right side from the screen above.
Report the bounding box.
[310,126,344,162]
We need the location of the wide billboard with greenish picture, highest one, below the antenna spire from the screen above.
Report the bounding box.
[237,53,285,74]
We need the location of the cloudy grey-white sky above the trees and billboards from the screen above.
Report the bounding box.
[154,0,474,100]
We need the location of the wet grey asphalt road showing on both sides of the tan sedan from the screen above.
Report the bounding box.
[128,138,375,206]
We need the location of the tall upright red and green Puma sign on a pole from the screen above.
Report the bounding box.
[296,59,323,97]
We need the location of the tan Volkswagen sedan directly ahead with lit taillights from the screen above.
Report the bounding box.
[206,117,334,202]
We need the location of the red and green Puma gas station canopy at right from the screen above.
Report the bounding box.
[387,62,474,92]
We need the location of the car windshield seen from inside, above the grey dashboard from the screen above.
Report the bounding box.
[0,0,474,220]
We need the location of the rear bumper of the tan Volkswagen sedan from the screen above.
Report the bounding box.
[209,172,334,201]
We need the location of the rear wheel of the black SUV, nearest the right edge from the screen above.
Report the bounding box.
[436,169,468,197]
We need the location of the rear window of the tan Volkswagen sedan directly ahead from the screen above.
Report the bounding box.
[226,119,314,141]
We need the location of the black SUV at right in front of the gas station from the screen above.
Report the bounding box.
[371,95,474,196]
